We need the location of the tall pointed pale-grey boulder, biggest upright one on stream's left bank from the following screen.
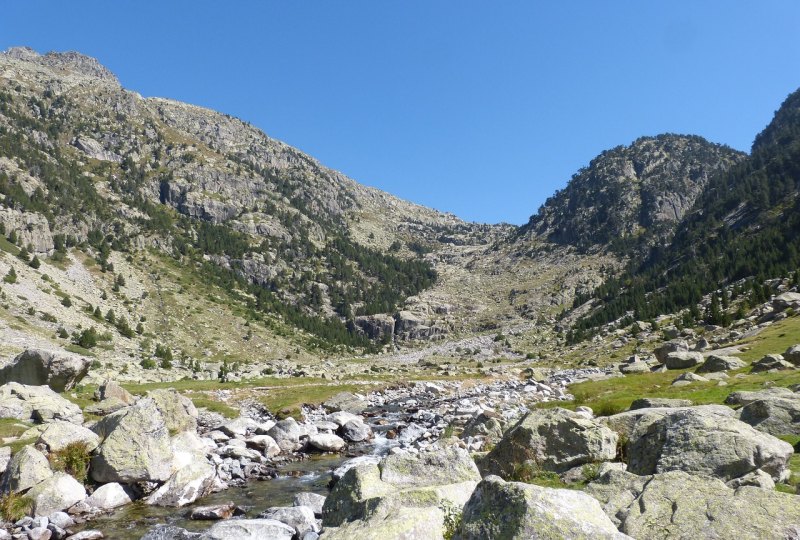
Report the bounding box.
[90,398,172,484]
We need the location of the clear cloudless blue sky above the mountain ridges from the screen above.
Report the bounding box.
[0,0,800,223]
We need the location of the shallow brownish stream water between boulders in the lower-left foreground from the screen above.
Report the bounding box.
[80,455,345,540]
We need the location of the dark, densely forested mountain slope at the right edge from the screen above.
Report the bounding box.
[578,90,800,333]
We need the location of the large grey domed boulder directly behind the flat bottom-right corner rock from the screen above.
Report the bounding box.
[626,407,793,480]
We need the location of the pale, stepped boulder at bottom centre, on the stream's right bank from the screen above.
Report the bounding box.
[322,447,480,534]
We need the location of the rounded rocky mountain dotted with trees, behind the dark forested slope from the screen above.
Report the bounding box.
[519,134,744,254]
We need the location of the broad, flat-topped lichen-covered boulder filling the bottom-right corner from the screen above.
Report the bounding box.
[586,471,800,540]
